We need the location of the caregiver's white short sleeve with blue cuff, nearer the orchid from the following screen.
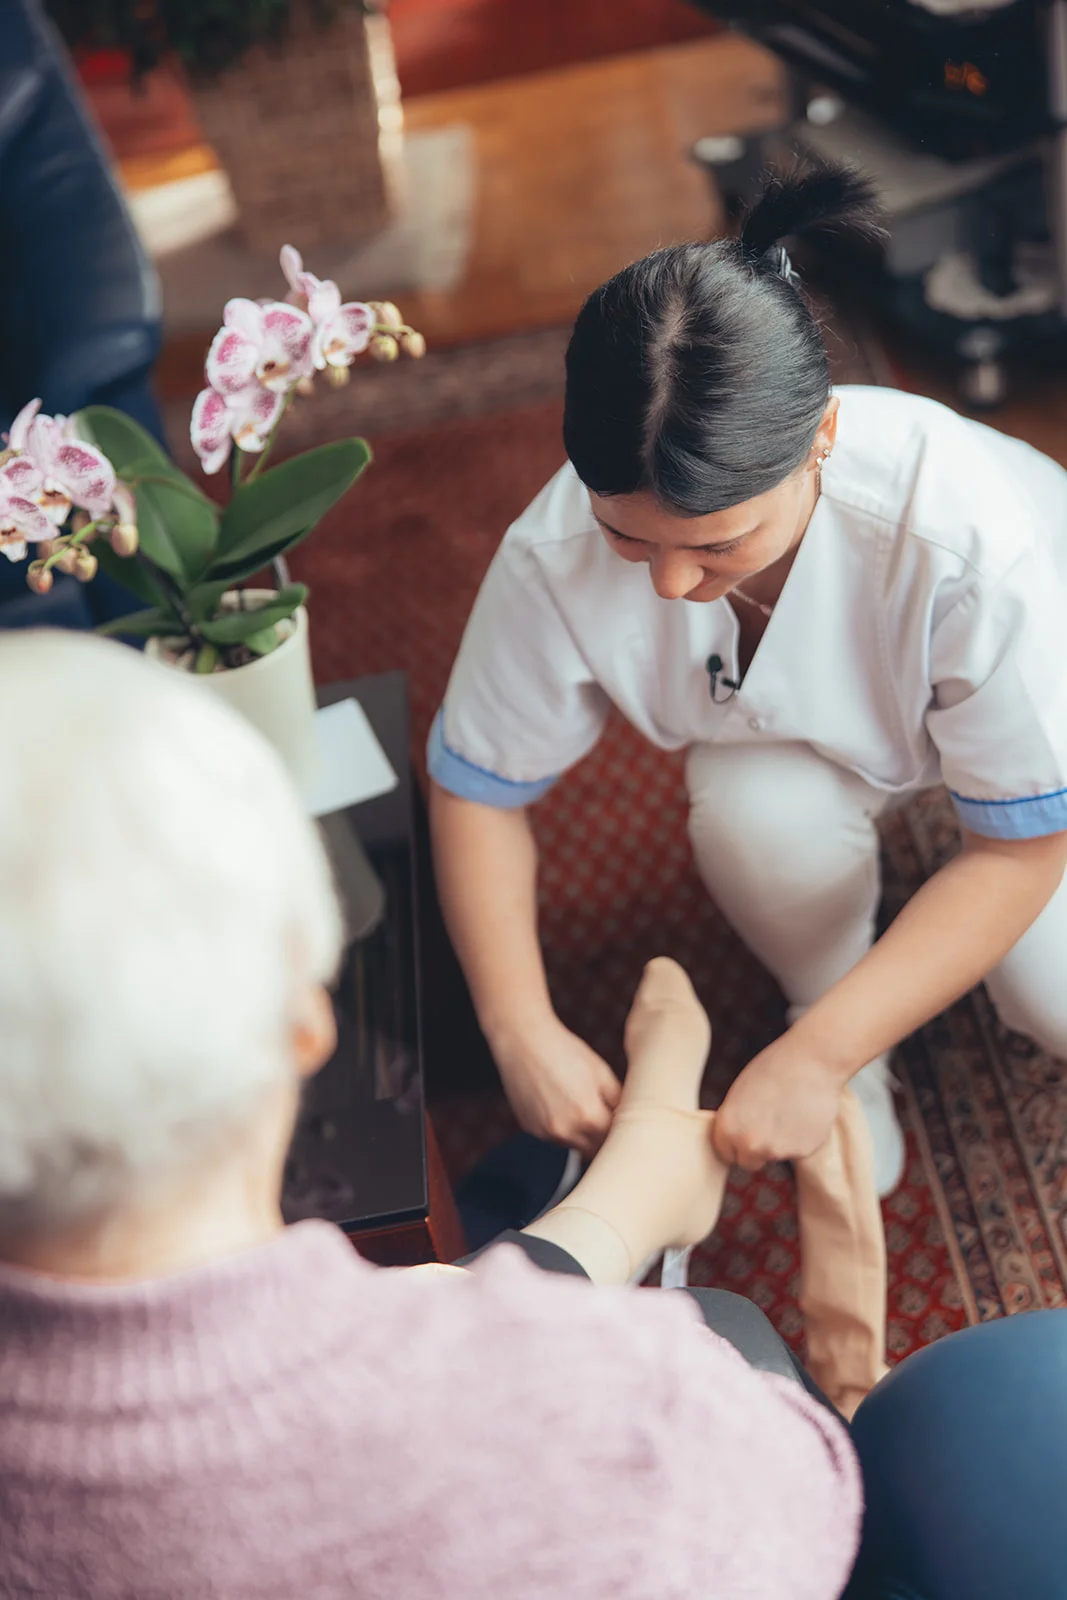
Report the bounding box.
[427,534,609,808]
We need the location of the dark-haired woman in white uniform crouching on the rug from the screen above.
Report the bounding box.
[430,170,1067,1194]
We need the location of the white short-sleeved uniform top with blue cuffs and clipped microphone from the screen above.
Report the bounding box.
[429,387,1067,838]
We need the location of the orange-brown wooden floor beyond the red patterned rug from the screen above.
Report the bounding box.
[147,35,781,397]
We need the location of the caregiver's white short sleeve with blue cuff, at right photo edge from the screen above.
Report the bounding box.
[926,550,1067,838]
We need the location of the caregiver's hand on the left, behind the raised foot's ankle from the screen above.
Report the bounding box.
[490,1014,622,1157]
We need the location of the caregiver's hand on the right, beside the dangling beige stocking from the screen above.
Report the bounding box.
[712,1032,841,1173]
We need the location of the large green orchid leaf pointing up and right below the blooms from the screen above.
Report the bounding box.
[213,438,371,576]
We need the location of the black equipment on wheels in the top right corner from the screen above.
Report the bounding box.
[693,0,1067,405]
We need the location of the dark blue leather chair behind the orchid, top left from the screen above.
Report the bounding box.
[0,0,163,627]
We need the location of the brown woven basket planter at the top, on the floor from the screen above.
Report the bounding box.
[197,3,402,251]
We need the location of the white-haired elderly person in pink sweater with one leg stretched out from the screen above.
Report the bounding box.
[0,634,859,1600]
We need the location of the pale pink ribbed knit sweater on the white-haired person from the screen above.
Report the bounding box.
[0,1222,859,1600]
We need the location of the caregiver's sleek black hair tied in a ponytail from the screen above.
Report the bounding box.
[563,166,875,517]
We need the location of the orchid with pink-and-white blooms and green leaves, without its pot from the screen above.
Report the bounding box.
[0,245,426,672]
